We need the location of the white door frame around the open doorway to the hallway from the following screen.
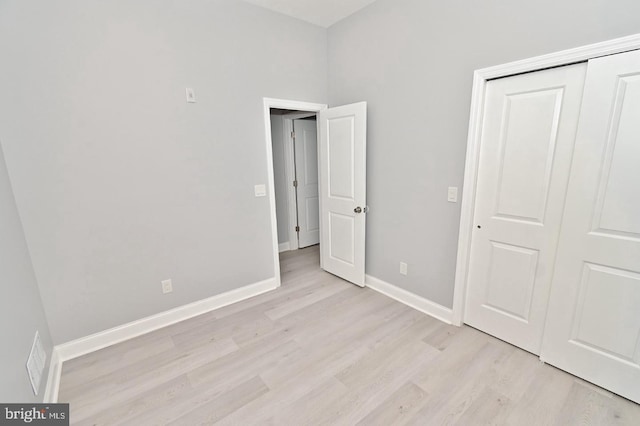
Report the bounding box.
[263,98,327,287]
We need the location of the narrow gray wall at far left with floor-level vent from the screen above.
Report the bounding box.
[0,144,52,402]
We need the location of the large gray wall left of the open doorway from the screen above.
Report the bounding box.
[0,0,327,343]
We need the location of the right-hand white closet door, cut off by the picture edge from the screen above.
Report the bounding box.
[541,51,640,403]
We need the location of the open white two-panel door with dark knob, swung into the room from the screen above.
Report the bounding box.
[318,102,367,286]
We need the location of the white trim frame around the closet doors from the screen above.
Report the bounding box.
[452,34,640,326]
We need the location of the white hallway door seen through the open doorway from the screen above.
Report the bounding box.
[293,119,320,248]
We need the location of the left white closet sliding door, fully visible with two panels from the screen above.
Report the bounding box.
[465,64,586,354]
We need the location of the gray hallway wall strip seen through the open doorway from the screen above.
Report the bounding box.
[271,114,289,244]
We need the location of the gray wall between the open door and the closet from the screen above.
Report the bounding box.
[328,0,640,307]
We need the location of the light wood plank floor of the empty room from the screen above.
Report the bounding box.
[59,247,640,426]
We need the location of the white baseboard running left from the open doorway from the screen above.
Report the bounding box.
[45,278,278,403]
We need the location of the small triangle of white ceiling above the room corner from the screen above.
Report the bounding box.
[244,0,375,28]
